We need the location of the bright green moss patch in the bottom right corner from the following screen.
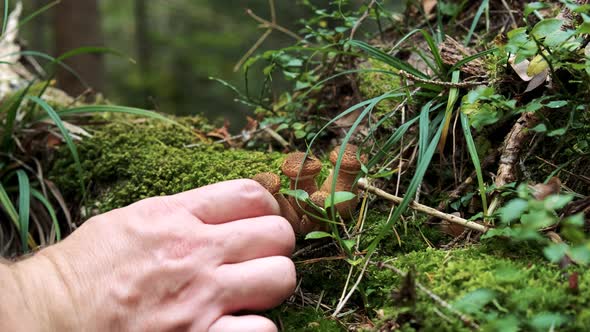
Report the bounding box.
[368,246,590,331]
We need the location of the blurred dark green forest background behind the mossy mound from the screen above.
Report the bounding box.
[21,0,322,130]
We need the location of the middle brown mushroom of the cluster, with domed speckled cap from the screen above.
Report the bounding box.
[281,152,322,215]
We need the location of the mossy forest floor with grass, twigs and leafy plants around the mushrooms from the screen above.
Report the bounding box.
[3,0,590,331]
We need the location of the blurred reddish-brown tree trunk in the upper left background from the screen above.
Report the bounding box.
[54,0,104,96]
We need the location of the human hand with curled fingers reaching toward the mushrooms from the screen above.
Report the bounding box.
[13,180,296,332]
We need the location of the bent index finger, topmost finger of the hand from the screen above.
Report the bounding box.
[170,179,280,224]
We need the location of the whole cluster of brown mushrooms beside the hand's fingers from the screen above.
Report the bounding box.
[253,144,367,235]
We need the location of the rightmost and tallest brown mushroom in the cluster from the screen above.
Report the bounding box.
[320,144,367,220]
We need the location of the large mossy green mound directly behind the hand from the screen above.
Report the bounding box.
[51,120,282,212]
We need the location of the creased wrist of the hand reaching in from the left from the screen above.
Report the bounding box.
[8,249,79,331]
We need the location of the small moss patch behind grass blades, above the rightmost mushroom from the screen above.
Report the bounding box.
[358,59,401,128]
